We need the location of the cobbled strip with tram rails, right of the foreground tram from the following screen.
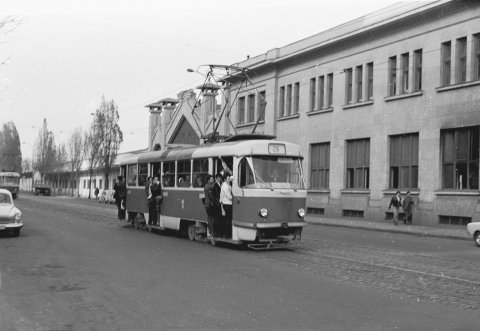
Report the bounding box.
[275,239,480,310]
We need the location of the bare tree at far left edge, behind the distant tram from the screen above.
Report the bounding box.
[0,122,22,172]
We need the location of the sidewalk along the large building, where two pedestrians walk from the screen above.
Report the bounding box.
[305,216,472,240]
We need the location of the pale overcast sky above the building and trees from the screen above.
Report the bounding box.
[0,0,410,158]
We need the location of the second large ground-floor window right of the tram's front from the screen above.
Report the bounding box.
[346,139,370,189]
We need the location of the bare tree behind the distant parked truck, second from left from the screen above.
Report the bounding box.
[34,118,55,181]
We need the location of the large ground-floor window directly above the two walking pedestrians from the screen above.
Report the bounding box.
[390,133,418,189]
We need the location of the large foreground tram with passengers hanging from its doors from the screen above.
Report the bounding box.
[121,134,307,249]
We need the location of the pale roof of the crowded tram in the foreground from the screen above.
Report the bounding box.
[131,139,301,164]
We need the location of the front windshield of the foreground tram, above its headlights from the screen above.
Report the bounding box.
[239,156,304,190]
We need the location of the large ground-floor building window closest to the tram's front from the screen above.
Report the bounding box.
[310,143,330,188]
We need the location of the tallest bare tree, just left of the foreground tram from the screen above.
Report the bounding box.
[95,96,123,189]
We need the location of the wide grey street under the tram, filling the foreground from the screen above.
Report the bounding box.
[0,194,480,331]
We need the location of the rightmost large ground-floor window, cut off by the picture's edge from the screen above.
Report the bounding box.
[441,126,479,190]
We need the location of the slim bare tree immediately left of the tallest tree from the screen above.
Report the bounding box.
[84,117,103,199]
